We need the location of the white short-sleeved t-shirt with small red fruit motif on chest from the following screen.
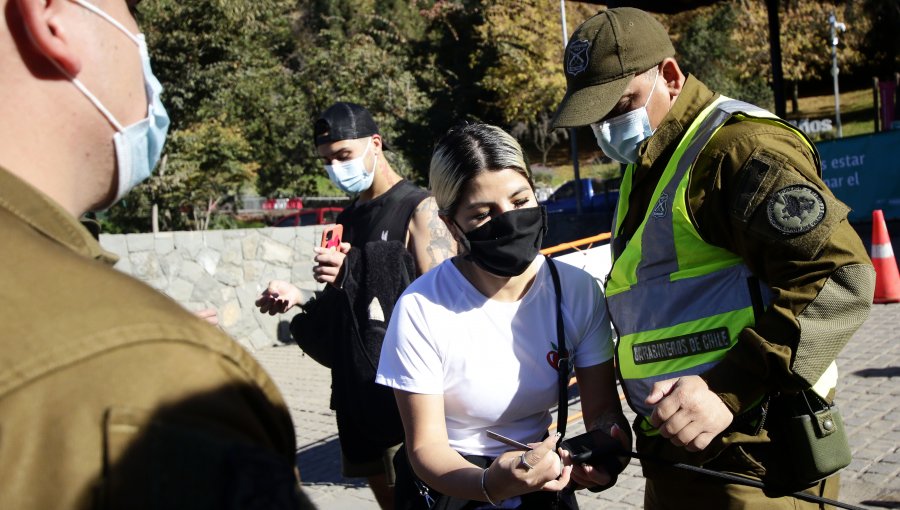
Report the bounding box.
[375,255,613,457]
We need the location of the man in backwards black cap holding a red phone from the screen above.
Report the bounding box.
[257,102,456,509]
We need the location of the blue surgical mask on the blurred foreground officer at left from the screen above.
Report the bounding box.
[61,0,169,207]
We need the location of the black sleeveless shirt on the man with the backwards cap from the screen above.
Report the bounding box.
[335,179,428,247]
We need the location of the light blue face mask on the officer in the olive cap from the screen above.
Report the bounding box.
[591,68,659,164]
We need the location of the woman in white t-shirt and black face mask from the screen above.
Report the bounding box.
[373,124,631,509]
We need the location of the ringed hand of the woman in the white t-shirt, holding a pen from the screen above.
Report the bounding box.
[485,435,572,501]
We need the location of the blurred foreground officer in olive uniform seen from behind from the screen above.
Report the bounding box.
[0,0,309,509]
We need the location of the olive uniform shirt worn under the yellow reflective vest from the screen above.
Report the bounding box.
[617,76,875,468]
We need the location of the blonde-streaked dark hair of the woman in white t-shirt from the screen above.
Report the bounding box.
[428,123,534,216]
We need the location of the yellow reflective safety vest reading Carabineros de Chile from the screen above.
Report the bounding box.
[606,96,837,426]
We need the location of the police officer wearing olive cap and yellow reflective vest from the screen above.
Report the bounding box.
[553,7,874,509]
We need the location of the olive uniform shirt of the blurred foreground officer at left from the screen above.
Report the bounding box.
[0,168,301,509]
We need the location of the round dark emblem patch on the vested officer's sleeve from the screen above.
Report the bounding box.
[766,184,825,235]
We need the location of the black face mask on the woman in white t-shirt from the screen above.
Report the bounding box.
[460,206,547,278]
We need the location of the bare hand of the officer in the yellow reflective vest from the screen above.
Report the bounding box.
[644,375,734,452]
